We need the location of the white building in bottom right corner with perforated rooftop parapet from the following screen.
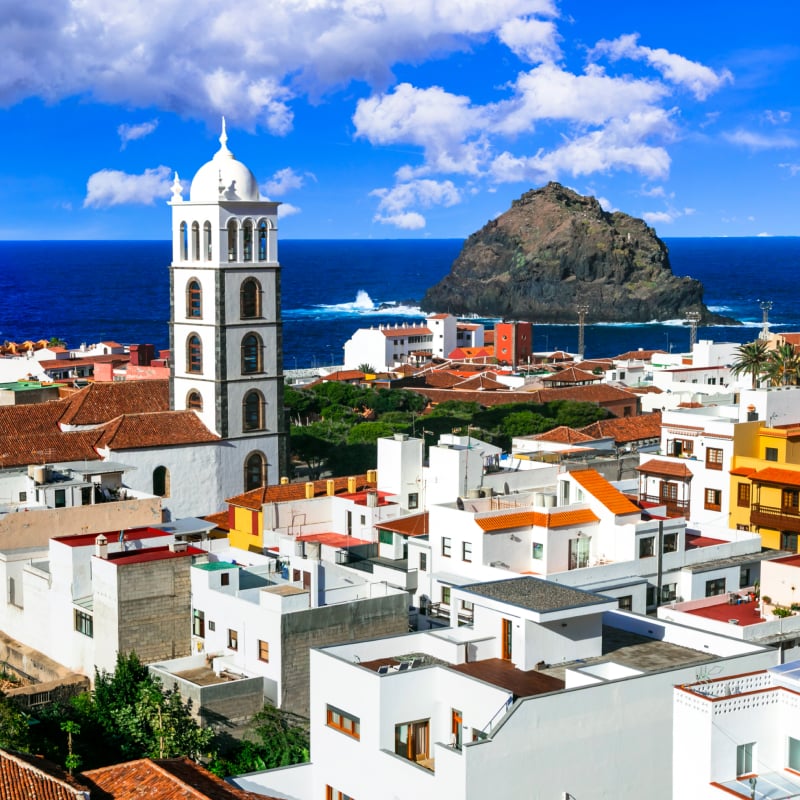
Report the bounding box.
[672,661,800,800]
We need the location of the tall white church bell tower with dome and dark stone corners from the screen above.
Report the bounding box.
[170,118,287,490]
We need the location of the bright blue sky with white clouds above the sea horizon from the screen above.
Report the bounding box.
[0,0,800,239]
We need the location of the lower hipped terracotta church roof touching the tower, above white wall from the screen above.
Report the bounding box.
[95,411,219,450]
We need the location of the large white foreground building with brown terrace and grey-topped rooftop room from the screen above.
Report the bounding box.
[232,577,777,800]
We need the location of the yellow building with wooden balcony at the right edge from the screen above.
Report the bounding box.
[730,424,800,553]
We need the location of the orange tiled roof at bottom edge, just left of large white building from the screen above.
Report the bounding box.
[81,758,275,800]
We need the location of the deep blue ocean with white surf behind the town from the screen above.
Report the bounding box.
[0,237,800,369]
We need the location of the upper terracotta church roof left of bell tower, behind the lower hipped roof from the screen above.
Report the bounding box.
[60,380,169,425]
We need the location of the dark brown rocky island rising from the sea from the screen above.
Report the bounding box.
[421,183,737,325]
